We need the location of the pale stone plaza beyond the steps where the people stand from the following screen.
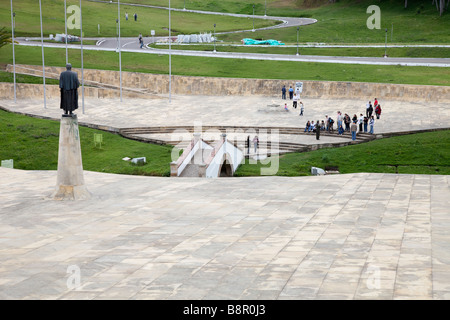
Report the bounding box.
[0,94,450,143]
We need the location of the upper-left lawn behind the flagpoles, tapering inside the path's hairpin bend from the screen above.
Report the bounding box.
[0,0,277,37]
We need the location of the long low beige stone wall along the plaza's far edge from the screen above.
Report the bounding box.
[1,65,450,102]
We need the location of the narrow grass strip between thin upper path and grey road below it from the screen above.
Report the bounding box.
[152,44,450,58]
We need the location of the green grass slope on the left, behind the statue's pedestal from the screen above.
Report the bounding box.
[0,110,176,176]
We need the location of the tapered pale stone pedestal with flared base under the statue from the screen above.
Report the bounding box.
[52,114,91,200]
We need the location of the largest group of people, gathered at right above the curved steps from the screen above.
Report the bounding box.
[303,98,381,140]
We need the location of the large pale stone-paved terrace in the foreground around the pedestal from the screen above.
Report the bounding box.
[0,168,450,300]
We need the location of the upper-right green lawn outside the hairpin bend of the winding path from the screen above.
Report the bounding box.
[117,0,450,43]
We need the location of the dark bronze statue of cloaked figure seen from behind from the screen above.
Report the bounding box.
[59,63,80,115]
